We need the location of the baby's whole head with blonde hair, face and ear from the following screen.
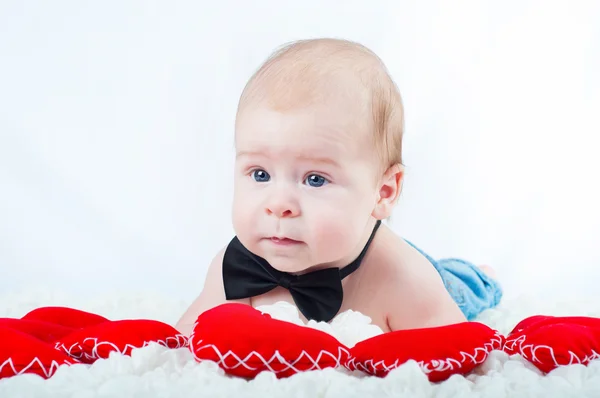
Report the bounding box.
[233,39,403,272]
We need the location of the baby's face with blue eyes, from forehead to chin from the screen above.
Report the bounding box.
[233,100,378,272]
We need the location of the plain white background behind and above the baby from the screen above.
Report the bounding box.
[0,0,600,300]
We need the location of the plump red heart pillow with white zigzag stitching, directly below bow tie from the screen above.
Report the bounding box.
[189,303,349,378]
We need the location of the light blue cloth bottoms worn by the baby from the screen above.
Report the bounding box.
[406,241,502,320]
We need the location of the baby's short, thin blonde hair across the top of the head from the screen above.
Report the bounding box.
[237,38,404,169]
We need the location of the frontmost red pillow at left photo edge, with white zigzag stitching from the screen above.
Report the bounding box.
[0,327,77,379]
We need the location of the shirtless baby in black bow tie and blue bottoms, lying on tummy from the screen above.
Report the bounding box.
[176,39,502,335]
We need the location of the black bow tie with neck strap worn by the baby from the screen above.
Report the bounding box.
[223,220,381,322]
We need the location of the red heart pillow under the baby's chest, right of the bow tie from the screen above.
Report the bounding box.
[346,322,503,382]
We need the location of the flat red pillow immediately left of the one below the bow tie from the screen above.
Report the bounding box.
[55,319,187,363]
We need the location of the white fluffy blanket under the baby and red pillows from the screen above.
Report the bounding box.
[0,290,600,398]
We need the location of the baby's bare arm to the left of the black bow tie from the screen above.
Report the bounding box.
[175,249,232,336]
